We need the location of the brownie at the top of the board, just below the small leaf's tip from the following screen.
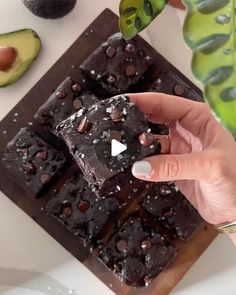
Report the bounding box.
[80,33,153,95]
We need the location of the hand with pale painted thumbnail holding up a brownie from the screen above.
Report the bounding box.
[129,93,236,243]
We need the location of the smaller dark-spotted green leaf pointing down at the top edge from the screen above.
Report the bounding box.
[119,0,168,39]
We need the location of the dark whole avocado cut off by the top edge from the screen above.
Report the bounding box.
[22,0,77,19]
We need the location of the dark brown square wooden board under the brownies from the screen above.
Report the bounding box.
[0,9,216,295]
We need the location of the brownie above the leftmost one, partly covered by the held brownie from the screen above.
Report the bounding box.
[34,77,98,133]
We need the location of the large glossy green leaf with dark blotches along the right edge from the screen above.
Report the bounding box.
[184,0,236,136]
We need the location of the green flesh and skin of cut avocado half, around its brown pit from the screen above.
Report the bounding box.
[0,29,41,87]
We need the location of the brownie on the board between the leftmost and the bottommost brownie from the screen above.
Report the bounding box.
[47,171,119,244]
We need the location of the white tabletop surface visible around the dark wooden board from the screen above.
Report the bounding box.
[0,0,236,295]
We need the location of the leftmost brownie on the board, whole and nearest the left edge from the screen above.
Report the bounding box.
[2,128,66,196]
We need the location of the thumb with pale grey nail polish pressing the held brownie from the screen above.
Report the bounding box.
[132,153,204,182]
